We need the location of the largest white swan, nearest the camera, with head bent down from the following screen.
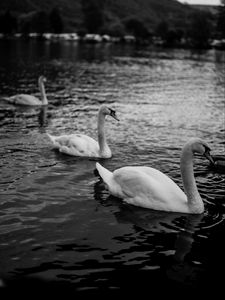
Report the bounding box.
[96,138,213,214]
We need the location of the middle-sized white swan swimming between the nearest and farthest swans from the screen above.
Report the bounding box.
[47,105,119,158]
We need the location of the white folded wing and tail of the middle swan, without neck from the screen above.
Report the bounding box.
[49,134,99,157]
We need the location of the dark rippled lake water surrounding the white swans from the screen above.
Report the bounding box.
[0,41,225,295]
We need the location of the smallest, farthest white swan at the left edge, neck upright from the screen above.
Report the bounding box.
[4,76,48,106]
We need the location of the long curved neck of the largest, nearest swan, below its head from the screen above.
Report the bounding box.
[180,144,204,213]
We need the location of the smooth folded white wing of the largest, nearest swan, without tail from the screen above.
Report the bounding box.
[113,167,187,212]
